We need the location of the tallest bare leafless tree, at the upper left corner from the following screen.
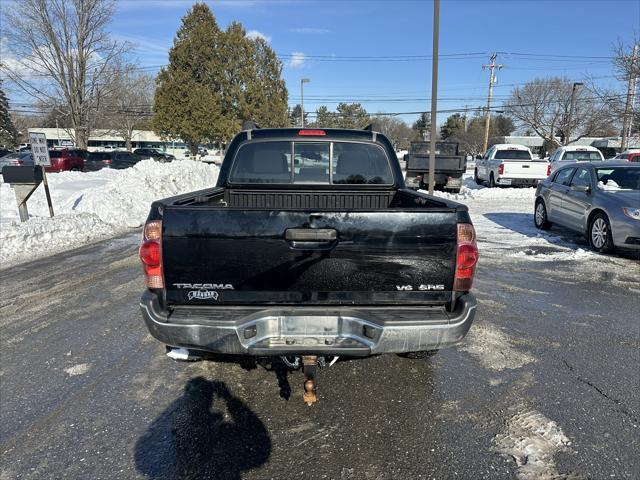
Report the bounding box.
[0,0,129,148]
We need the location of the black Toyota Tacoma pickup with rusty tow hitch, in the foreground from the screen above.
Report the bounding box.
[140,128,478,401]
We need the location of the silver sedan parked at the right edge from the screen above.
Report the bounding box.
[534,161,640,253]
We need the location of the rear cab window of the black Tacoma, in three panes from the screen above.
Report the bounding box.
[229,142,393,185]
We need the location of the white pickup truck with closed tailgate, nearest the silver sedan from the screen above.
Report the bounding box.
[473,143,551,187]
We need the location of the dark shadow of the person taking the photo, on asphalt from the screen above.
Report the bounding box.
[135,377,271,480]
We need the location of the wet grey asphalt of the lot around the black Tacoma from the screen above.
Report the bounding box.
[0,233,640,480]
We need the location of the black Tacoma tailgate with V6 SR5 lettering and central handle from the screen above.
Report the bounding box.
[162,206,457,305]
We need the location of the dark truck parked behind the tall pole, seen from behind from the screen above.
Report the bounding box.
[404,142,467,193]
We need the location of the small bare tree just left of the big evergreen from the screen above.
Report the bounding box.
[103,66,155,151]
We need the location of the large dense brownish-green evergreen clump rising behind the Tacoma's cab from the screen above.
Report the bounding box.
[154,3,288,151]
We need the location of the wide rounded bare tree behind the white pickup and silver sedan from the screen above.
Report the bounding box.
[503,77,612,146]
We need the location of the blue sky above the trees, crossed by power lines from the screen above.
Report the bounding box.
[15,0,640,123]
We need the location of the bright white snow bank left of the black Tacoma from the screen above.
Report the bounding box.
[0,160,218,268]
